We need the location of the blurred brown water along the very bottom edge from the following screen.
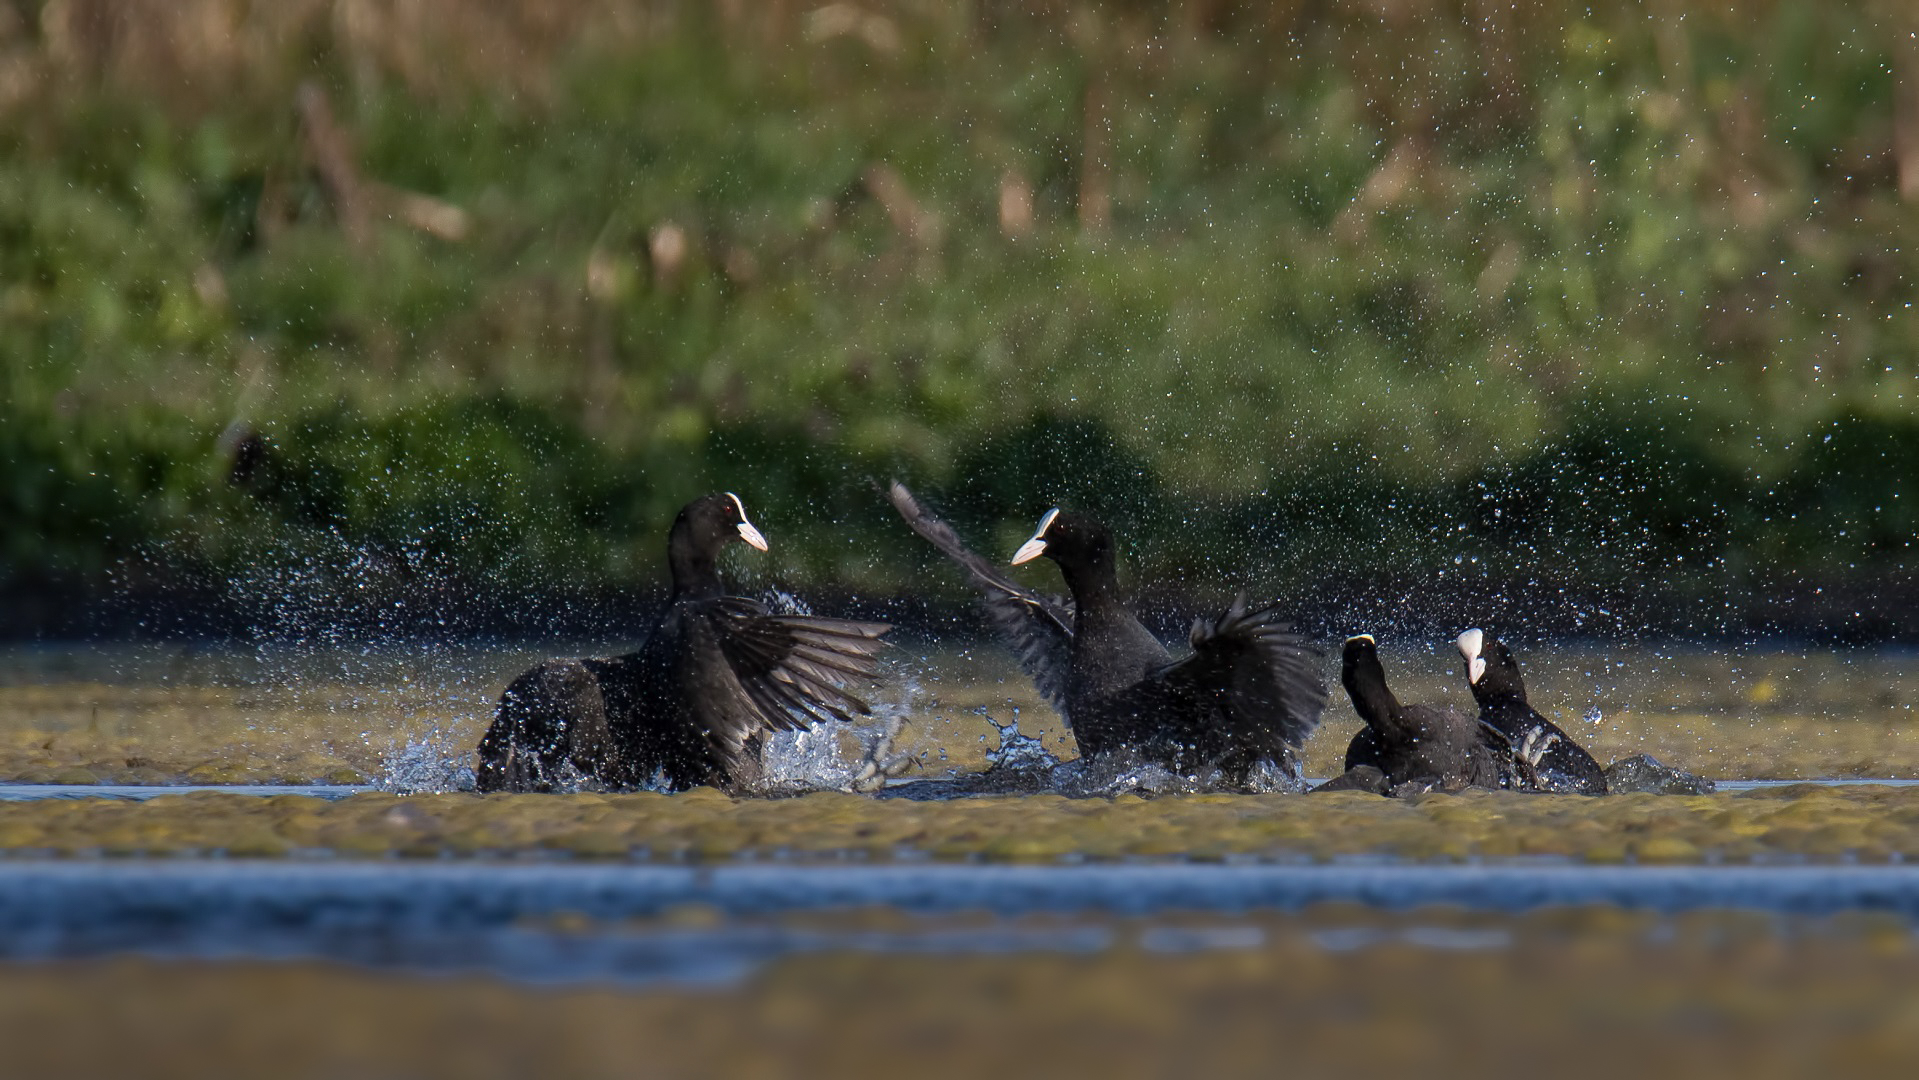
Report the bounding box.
[14,905,1919,1080]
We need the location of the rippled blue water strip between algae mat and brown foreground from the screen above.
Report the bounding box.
[11,863,1919,984]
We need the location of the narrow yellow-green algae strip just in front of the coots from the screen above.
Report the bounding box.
[0,785,1919,863]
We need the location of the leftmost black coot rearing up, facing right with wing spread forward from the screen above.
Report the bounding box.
[478,493,890,790]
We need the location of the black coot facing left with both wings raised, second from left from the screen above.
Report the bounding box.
[892,483,1326,787]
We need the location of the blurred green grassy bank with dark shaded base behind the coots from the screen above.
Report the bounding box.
[0,0,1919,618]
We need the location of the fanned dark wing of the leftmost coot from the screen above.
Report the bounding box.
[695,597,892,740]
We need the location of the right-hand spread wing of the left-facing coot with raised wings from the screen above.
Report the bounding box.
[1149,597,1326,762]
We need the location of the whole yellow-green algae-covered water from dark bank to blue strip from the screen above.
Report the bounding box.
[0,641,1919,863]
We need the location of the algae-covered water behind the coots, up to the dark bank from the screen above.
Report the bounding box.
[11,639,1919,787]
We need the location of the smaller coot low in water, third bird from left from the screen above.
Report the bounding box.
[1320,633,1512,790]
